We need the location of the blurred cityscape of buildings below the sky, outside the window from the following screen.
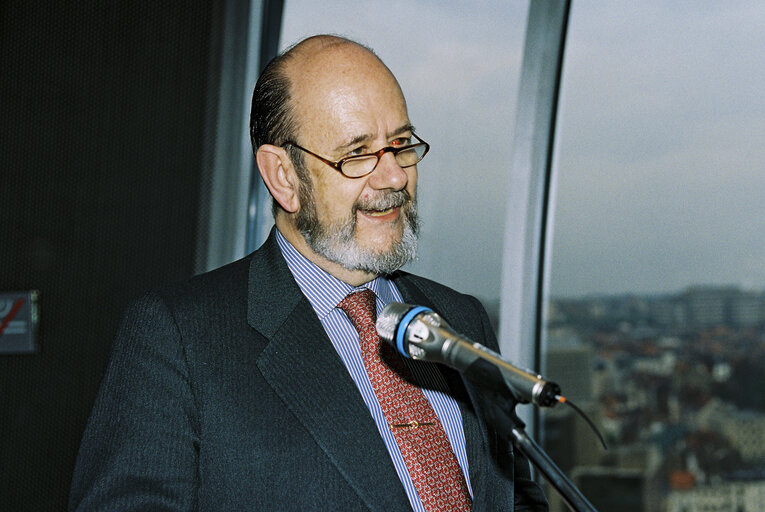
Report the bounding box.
[541,286,765,512]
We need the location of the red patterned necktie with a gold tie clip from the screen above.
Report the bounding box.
[338,289,472,512]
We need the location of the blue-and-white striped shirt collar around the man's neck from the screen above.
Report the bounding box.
[276,229,396,320]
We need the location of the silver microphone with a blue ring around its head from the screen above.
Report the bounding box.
[377,302,565,407]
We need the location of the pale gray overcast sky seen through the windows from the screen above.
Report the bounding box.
[283,0,765,300]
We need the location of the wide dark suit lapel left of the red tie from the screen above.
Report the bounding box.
[248,233,409,511]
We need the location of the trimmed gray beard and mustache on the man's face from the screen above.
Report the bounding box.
[296,182,419,275]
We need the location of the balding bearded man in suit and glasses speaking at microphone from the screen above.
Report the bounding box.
[70,36,546,511]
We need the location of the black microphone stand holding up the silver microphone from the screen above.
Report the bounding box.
[468,363,597,512]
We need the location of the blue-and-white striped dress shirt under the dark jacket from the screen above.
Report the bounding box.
[276,230,473,512]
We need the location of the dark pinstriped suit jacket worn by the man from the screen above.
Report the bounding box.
[70,230,544,512]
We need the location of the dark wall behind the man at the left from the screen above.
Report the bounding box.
[0,0,219,511]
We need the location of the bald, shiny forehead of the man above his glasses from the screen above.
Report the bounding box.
[288,44,409,148]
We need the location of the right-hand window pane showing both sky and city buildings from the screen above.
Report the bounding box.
[543,0,765,512]
